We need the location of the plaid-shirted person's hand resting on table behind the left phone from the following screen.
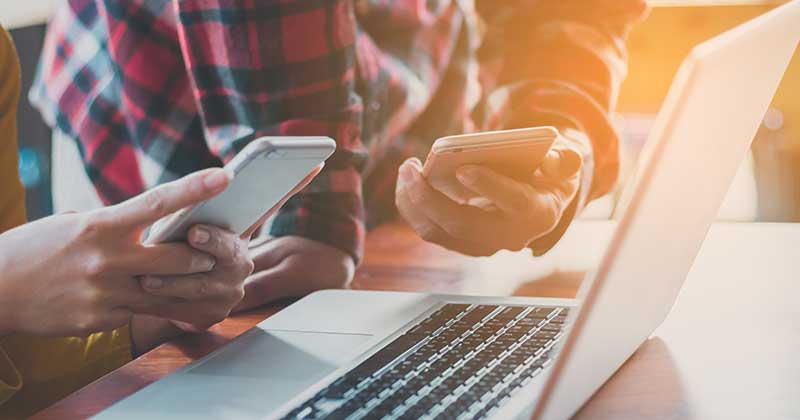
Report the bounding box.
[236,236,356,311]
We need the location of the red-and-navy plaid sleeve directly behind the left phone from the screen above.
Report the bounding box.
[174,0,366,260]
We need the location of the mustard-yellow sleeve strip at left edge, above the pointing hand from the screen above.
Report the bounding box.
[0,28,25,233]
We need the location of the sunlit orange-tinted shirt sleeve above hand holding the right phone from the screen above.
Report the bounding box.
[478,0,647,255]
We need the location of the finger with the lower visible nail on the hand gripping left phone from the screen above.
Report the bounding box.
[140,274,236,301]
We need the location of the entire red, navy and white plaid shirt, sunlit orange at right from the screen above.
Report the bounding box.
[30,0,646,259]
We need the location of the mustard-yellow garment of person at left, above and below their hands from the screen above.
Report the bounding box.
[0,28,131,419]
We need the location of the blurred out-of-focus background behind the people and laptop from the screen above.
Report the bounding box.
[0,0,800,222]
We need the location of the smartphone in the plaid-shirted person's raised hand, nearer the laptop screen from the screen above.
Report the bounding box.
[422,126,559,204]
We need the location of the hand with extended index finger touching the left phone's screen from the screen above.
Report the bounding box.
[0,169,230,336]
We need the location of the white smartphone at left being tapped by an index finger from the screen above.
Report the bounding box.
[144,137,336,244]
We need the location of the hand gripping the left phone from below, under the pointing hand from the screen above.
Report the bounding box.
[137,165,323,332]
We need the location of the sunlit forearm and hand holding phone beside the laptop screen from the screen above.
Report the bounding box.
[395,0,644,255]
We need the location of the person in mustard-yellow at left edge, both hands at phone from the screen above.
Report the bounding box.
[0,27,282,418]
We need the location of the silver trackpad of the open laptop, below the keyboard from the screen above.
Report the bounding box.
[115,327,372,420]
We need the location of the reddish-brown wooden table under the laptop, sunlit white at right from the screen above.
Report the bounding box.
[31,221,800,419]
